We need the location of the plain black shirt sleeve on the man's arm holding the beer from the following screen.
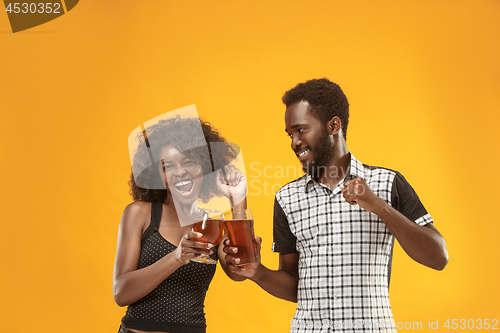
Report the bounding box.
[273,198,297,253]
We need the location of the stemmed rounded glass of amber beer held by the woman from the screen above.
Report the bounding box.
[191,208,224,264]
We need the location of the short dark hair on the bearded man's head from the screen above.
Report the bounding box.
[282,78,349,139]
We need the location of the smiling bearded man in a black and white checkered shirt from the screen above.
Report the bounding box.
[224,79,448,332]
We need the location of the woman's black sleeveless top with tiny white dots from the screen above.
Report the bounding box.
[122,202,218,333]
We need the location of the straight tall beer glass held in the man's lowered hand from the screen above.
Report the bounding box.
[223,209,257,266]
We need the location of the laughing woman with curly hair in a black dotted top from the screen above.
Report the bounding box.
[113,117,247,333]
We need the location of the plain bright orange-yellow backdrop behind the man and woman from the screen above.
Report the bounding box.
[0,0,500,333]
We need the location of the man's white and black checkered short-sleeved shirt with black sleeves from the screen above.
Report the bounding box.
[273,154,432,333]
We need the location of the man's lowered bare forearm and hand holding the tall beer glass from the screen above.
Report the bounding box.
[224,237,299,302]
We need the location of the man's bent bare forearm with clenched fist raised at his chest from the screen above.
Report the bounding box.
[342,178,448,270]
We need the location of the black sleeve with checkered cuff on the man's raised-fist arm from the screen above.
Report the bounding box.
[391,172,432,225]
